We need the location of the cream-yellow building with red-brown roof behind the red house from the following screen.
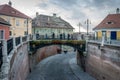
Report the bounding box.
[0,2,32,37]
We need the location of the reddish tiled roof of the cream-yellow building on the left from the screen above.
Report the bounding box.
[0,4,30,19]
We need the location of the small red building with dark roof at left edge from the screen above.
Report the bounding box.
[0,18,11,40]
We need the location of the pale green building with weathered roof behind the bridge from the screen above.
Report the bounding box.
[32,13,74,38]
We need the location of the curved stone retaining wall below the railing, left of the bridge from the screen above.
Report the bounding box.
[9,44,29,80]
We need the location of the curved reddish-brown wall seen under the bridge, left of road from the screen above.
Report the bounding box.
[29,45,61,72]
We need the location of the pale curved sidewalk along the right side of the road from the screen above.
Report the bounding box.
[69,58,96,80]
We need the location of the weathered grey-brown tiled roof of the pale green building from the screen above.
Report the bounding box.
[32,15,74,29]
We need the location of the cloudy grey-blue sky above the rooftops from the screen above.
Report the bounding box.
[0,0,120,32]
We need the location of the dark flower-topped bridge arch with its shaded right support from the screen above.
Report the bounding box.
[29,40,86,71]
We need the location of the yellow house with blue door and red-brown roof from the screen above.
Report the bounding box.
[93,9,120,40]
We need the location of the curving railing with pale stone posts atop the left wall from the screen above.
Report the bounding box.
[0,36,35,80]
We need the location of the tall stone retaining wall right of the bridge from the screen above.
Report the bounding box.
[86,42,120,80]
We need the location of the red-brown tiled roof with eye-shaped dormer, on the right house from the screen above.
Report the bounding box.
[93,14,120,30]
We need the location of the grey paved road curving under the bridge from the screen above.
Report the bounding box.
[27,53,79,80]
